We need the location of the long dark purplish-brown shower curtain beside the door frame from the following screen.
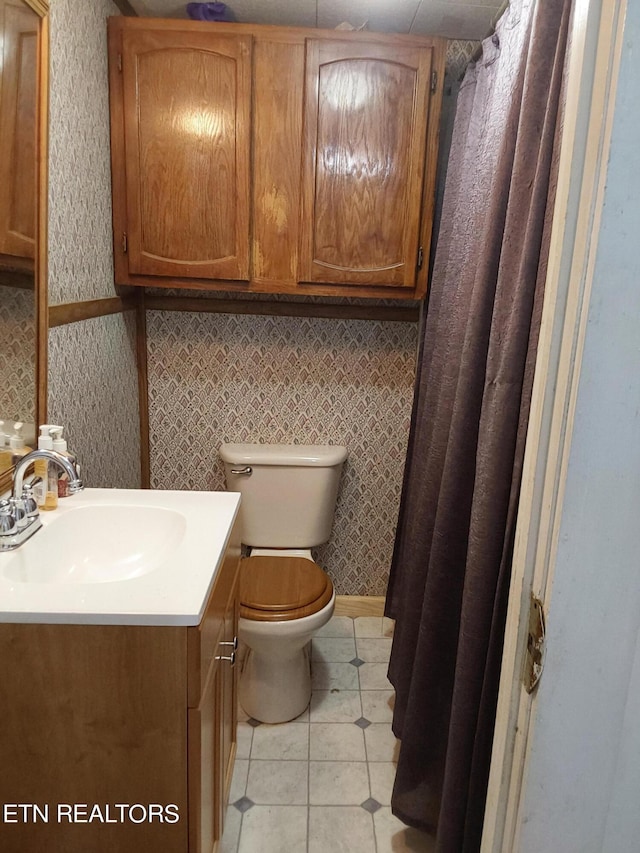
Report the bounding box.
[386,0,570,853]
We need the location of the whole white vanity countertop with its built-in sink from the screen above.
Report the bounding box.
[0,489,240,625]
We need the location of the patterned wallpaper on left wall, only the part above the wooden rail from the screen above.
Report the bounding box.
[49,0,119,305]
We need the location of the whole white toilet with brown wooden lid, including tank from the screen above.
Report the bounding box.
[220,444,347,723]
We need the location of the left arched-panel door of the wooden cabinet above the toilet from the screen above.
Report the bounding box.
[122,30,251,279]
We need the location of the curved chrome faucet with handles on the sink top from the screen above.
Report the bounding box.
[0,450,84,551]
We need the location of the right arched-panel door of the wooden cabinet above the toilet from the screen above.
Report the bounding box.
[299,39,432,288]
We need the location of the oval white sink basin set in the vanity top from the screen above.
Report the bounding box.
[3,505,187,584]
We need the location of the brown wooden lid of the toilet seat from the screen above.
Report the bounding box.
[240,557,333,622]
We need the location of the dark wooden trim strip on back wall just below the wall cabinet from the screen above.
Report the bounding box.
[145,294,420,323]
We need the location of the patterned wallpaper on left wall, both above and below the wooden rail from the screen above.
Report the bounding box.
[48,0,140,488]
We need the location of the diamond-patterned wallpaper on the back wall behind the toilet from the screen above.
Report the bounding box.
[147,311,417,595]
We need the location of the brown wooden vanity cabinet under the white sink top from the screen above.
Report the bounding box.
[0,523,240,853]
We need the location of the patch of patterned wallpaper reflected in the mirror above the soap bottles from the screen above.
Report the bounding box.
[0,287,36,432]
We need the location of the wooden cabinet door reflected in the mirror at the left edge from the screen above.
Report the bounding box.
[0,0,39,258]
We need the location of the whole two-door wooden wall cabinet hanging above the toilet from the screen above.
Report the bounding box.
[109,17,445,299]
